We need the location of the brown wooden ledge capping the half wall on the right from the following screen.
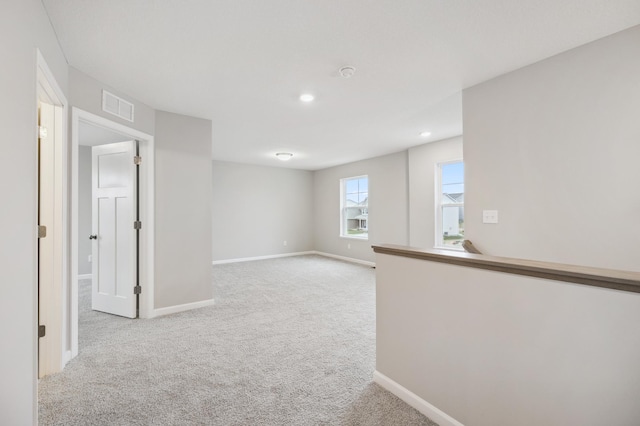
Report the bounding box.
[371,244,640,293]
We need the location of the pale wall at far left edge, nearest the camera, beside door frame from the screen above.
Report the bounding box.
[0,0,67,425]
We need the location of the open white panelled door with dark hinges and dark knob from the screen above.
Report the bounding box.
[90,141,137,318]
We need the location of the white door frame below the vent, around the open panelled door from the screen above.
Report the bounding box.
[69,107,155,357]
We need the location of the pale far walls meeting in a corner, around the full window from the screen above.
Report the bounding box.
[213,137,462,261]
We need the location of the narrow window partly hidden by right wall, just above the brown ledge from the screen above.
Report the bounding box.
[436,161,464,250]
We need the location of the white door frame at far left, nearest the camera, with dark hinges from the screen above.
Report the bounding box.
[34,48,70,377]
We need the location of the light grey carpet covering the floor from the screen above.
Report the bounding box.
[39,256,435,426]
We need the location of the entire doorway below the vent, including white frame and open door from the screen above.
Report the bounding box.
[70,108,154,356]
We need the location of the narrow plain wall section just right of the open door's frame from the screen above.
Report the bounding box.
[154,111,213,309]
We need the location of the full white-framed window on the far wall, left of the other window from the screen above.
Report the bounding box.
[340,176,369,239]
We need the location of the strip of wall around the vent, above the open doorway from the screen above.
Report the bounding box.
[69,67,155,135]
